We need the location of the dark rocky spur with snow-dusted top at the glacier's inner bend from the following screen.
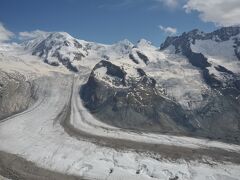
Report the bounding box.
[80,61,193,133]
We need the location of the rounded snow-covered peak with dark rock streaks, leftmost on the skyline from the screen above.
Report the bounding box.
[22,32,88,72]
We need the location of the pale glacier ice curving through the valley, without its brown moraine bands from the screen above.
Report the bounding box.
[0,57,240,180]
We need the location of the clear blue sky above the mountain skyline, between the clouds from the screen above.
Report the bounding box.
[0,0,239,46]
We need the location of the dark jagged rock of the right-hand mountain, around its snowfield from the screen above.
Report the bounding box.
[161,27,240,98]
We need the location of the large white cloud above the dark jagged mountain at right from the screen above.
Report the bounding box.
[184,0,240,26]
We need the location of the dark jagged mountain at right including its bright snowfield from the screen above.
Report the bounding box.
[161,27,240,86]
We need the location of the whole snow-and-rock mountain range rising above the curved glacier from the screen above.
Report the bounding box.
[15,27,240,142]
